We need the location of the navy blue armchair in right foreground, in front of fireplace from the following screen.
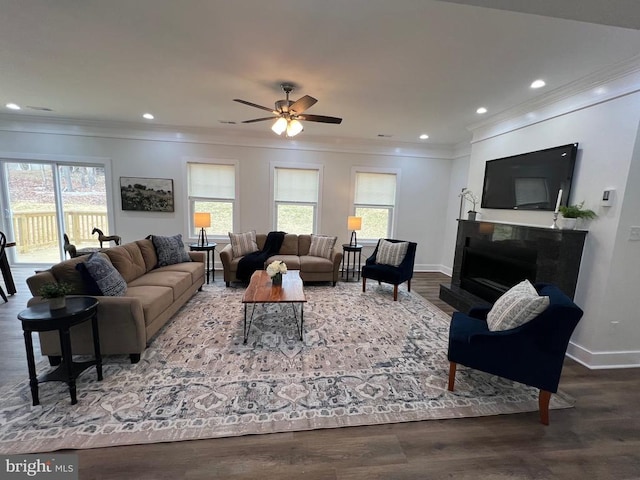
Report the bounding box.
[448,283,583,425]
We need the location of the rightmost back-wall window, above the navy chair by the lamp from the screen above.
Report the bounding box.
[353,172,397,240]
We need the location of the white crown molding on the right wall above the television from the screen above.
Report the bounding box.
[467,55,640,143]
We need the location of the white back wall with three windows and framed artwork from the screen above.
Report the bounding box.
[0,118,452,270]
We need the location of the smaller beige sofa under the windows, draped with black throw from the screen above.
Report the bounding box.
[220,233,342,286]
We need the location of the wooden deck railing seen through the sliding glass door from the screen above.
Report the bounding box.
[13,211,109,253]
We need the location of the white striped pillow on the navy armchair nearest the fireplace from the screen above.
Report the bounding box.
[487,280,549,332]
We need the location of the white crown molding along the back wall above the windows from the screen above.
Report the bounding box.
[0,113,454,159]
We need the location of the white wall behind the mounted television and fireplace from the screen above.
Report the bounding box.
[469,92,640,367]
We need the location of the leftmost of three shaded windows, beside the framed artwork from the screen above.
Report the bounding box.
[187,163,236,237]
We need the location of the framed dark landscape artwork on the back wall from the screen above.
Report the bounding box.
[120,177,174,212]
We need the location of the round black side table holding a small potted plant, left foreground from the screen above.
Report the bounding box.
[18,297,102,405]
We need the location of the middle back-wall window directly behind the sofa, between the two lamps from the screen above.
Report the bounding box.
[273,167,320,234]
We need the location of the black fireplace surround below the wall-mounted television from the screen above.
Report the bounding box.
[440,220,587,312]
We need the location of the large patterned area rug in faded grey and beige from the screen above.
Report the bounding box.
[0,283,573,454]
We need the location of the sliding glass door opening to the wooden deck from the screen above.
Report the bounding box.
[2,161,109,264]
